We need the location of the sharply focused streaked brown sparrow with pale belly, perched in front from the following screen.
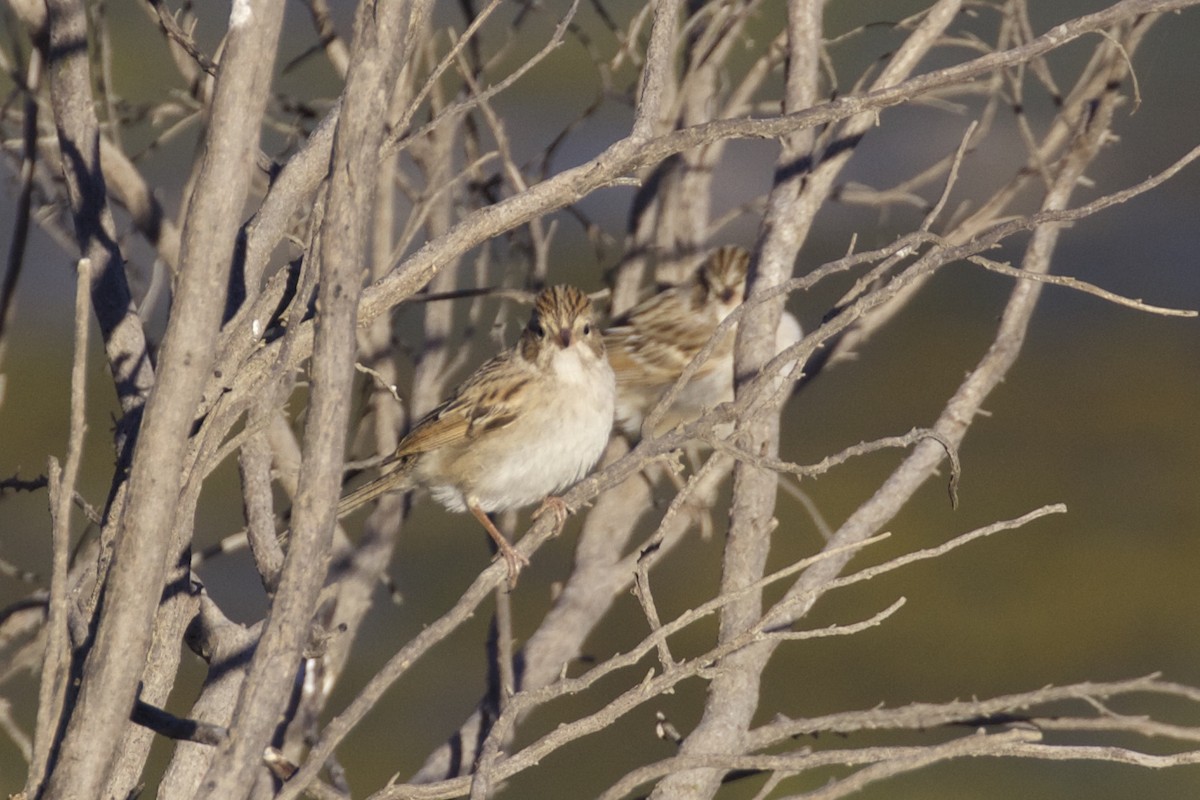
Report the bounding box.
[337,285,616,588]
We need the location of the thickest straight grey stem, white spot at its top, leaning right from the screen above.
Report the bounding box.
[39,0,282,798]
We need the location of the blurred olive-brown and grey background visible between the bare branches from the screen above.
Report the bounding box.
[0,0,1200,800]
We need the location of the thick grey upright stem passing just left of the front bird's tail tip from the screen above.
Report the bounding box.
[189,2,408,800]
